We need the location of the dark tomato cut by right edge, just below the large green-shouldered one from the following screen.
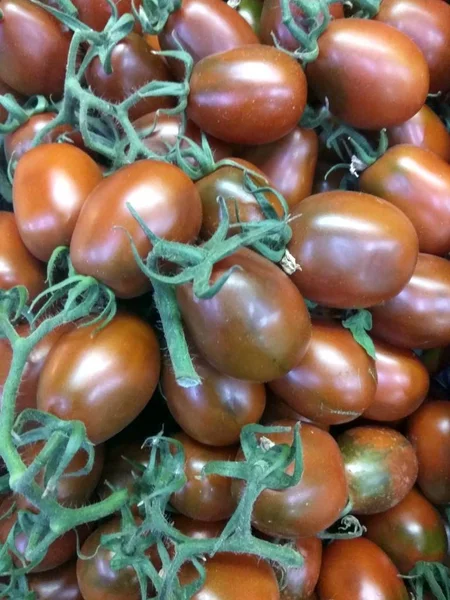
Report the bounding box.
[371,254,450,349]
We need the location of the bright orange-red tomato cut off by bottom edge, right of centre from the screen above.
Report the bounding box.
[318,538,410,600]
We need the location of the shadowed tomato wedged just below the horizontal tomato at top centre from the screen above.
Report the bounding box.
[239,127,318,208]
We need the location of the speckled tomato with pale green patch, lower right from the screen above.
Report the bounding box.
[337,427,418,515]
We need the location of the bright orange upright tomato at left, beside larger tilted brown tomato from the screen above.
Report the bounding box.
[13,144,103,261]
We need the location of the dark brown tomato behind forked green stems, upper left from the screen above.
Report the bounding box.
[86,33,174,119]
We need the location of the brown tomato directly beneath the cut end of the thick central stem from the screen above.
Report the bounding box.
[161,354,266,446]
